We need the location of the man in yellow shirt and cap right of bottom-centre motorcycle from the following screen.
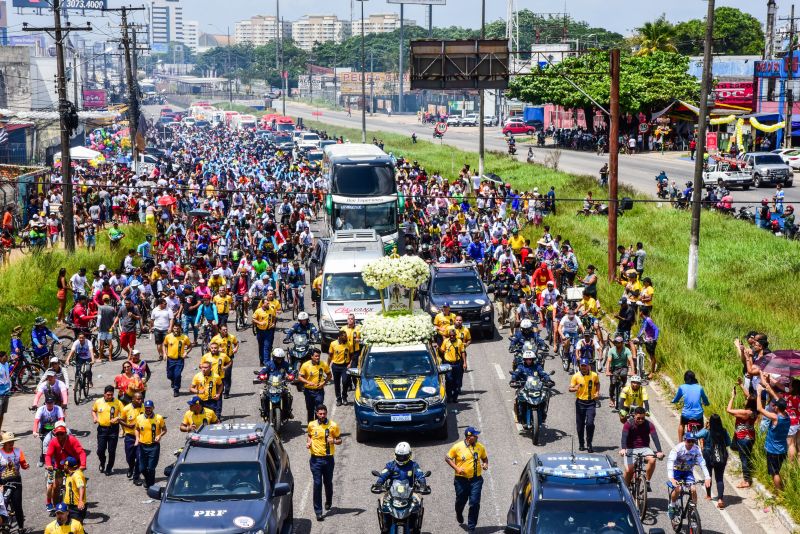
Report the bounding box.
[444,426,489,532]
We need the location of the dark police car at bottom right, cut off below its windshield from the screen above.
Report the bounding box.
[506,453,664,534]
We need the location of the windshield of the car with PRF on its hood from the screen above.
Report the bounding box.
[167,462,264,501]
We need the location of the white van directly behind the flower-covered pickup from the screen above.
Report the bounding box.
[317,230,386,346]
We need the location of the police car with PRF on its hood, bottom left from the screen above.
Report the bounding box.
[147,423,294,534]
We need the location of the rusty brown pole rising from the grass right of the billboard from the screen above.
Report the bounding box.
[608,48,619,282]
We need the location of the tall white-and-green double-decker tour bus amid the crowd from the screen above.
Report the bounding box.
[322,143,403,251]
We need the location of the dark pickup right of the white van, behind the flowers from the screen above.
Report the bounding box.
[419,263,494,339]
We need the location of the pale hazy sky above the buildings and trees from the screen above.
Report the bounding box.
[3,0,772,40]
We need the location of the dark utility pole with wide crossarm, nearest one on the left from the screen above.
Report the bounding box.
[22,0,92,253]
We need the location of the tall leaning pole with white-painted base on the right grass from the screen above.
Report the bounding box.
[686,0,716,289]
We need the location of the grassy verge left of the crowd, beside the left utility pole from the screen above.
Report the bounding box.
[0,224,148,347]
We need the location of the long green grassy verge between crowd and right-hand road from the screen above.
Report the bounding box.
[306,121,800,520]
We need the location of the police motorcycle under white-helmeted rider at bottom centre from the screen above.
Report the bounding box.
[371,471,431,534]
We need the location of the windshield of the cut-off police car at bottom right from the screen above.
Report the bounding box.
[531,500,638,534]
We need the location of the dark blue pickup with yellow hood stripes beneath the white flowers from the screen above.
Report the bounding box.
[347,343,450,443]
